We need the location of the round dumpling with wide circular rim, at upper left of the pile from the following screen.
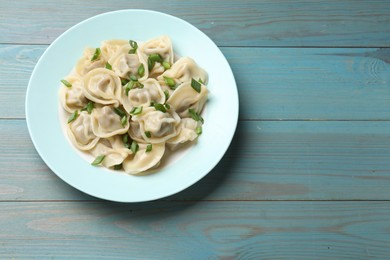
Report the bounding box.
[84,68,122,106]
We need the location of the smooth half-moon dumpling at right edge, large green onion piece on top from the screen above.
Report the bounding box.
[167,82,208,117]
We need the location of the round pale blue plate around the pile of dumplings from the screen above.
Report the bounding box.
[26,10,238,202]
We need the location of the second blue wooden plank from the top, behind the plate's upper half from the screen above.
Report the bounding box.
[0,45,390,120]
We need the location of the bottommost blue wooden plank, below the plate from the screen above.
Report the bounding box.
[0,202,390,259]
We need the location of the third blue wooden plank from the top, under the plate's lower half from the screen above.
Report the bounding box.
[0,120,390,201]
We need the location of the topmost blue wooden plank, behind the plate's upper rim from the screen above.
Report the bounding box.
[0,0,390,47]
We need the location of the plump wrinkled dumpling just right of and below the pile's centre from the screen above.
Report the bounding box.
[132,107,180,144]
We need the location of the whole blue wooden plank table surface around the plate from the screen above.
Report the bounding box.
[0,0,390,259]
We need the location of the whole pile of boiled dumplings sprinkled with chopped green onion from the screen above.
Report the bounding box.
[59,35,209,174]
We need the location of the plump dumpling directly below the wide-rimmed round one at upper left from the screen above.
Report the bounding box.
[91,106,129,138]
